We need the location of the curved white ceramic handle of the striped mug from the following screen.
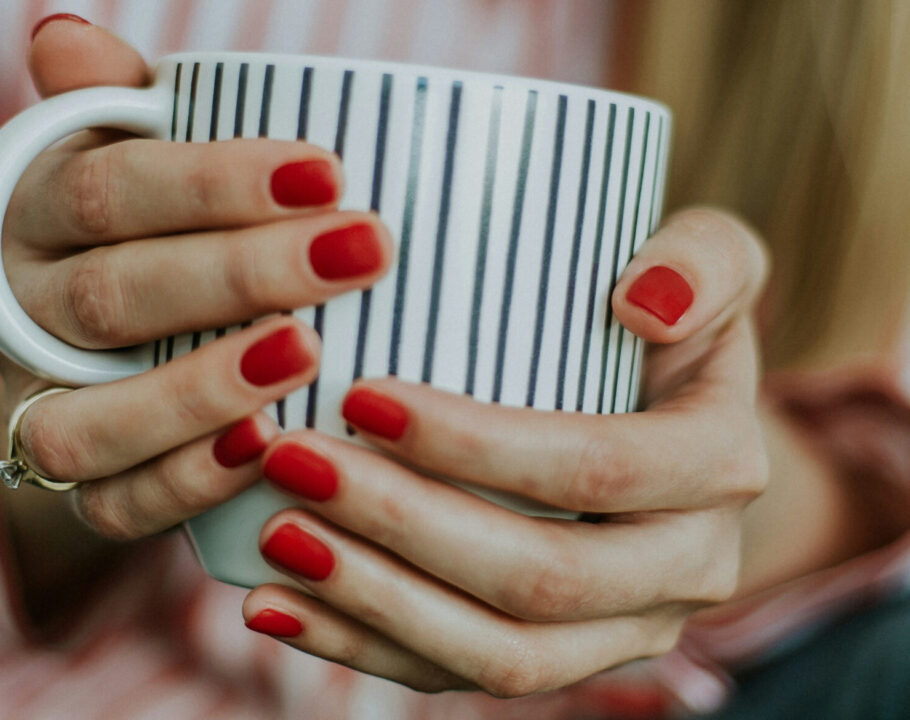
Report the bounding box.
[0,85,173,385]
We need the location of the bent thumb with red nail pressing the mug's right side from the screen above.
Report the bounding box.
[612,208,768,405]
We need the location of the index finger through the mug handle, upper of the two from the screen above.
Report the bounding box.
[8,137,342,251]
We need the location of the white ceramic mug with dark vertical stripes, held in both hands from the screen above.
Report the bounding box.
[0,52,670,586]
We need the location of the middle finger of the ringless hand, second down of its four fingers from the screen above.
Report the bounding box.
[263,432,739,621]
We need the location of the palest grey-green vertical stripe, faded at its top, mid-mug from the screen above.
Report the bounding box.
[464,85,502,395]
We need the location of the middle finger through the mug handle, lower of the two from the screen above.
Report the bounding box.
[13,212,393,348]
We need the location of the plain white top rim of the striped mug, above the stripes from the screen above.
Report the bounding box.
[155,50,673,120]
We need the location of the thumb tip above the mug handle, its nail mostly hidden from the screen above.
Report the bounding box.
[28,13,149,97]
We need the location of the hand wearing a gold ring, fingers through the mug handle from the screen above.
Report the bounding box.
[0,19,392,539]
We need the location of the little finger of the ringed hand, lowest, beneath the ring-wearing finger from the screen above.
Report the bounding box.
[76,413,280,540]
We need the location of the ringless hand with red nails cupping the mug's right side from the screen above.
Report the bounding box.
[243,210,767,697]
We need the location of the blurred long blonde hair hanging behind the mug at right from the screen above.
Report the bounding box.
[628,0,910,366]
